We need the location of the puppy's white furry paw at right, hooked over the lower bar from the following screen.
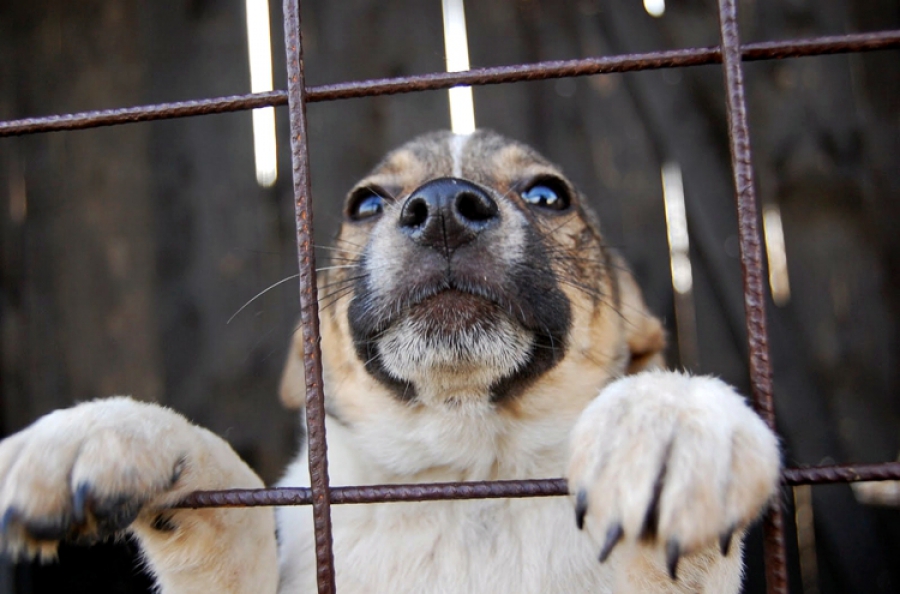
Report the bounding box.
[568,371,780,578]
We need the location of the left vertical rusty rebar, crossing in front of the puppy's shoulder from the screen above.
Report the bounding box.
[284,0,335,594]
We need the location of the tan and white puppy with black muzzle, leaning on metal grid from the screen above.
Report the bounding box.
[0,130,780,594]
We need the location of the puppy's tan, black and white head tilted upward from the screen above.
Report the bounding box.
[282,131,663,423]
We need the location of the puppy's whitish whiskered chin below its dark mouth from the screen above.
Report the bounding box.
[378,290,534,404]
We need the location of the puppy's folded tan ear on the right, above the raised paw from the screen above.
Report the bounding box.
[612,254,666,373]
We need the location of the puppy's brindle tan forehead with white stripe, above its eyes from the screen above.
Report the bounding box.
[363,131,561,191]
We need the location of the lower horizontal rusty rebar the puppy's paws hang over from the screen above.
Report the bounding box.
[177,462,900,508]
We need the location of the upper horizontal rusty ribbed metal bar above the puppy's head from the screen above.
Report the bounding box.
[0,31,900,137]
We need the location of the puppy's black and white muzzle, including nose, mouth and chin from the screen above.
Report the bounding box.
[347,177,571,401]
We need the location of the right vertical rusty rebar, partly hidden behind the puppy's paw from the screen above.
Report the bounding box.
[719,0,788,594]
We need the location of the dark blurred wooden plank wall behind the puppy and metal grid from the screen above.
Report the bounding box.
[0,0,900,594]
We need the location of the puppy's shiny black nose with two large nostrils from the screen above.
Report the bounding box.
[399,177,500,252]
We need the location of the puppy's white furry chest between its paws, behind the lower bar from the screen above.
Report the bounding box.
[278,408,612,594]
